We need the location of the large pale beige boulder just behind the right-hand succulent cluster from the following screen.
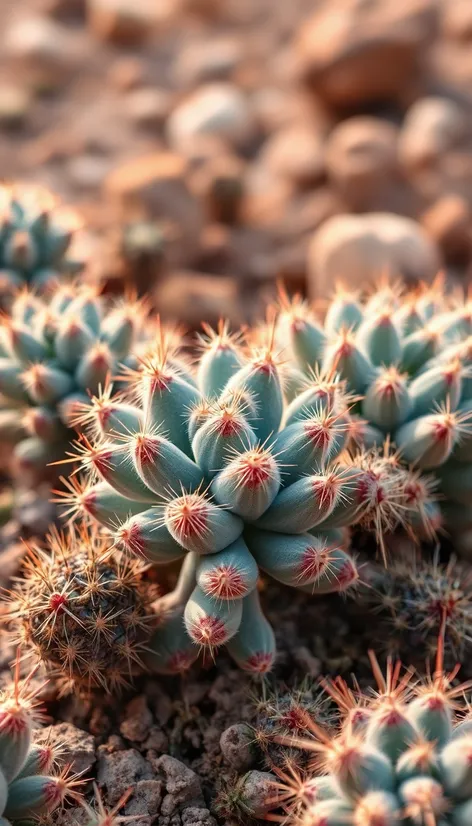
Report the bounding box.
[308,212,441,298]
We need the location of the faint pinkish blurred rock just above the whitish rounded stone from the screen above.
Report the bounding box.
[172,37,245,89]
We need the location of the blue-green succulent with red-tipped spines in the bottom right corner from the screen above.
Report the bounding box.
[264,644,472,826]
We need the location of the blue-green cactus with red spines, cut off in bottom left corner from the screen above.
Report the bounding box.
[0,655,82,826]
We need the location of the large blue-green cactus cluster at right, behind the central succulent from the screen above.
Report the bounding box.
[279,279,472,548]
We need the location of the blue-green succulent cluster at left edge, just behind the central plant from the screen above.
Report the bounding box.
[0,284,151,475]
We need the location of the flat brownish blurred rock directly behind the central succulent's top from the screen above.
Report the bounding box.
[154,271,245,330]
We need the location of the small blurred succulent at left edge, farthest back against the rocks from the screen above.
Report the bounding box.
[0,186,83,303]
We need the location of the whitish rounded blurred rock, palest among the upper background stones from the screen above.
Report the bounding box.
[167,83,254,151]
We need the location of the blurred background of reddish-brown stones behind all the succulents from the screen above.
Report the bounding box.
[0,0,472,326]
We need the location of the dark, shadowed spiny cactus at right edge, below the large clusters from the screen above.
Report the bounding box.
[365,558,472,663]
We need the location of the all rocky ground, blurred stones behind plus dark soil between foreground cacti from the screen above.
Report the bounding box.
[0,0,472,826]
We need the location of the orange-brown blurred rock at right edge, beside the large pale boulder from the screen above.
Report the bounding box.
[422,195,472,264]
